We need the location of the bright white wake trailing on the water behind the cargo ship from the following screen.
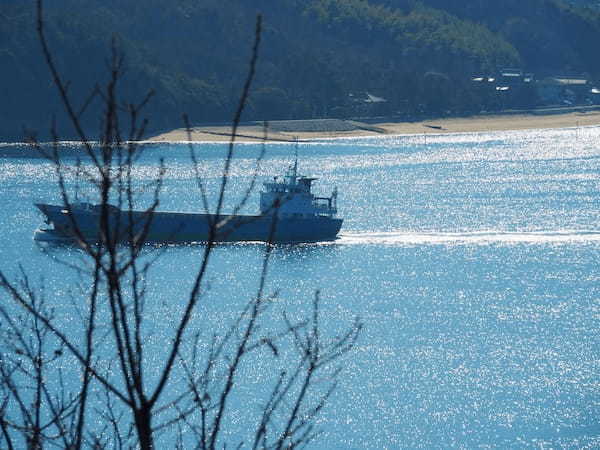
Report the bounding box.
[335,230,600,245]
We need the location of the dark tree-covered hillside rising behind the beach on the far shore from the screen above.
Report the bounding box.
[0,0,600,139]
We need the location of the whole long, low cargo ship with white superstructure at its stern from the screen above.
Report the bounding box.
[34,160,343,243]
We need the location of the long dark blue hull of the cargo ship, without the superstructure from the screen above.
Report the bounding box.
[34,204,342,243]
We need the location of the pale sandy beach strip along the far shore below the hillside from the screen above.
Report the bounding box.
[148,110,600,142]
